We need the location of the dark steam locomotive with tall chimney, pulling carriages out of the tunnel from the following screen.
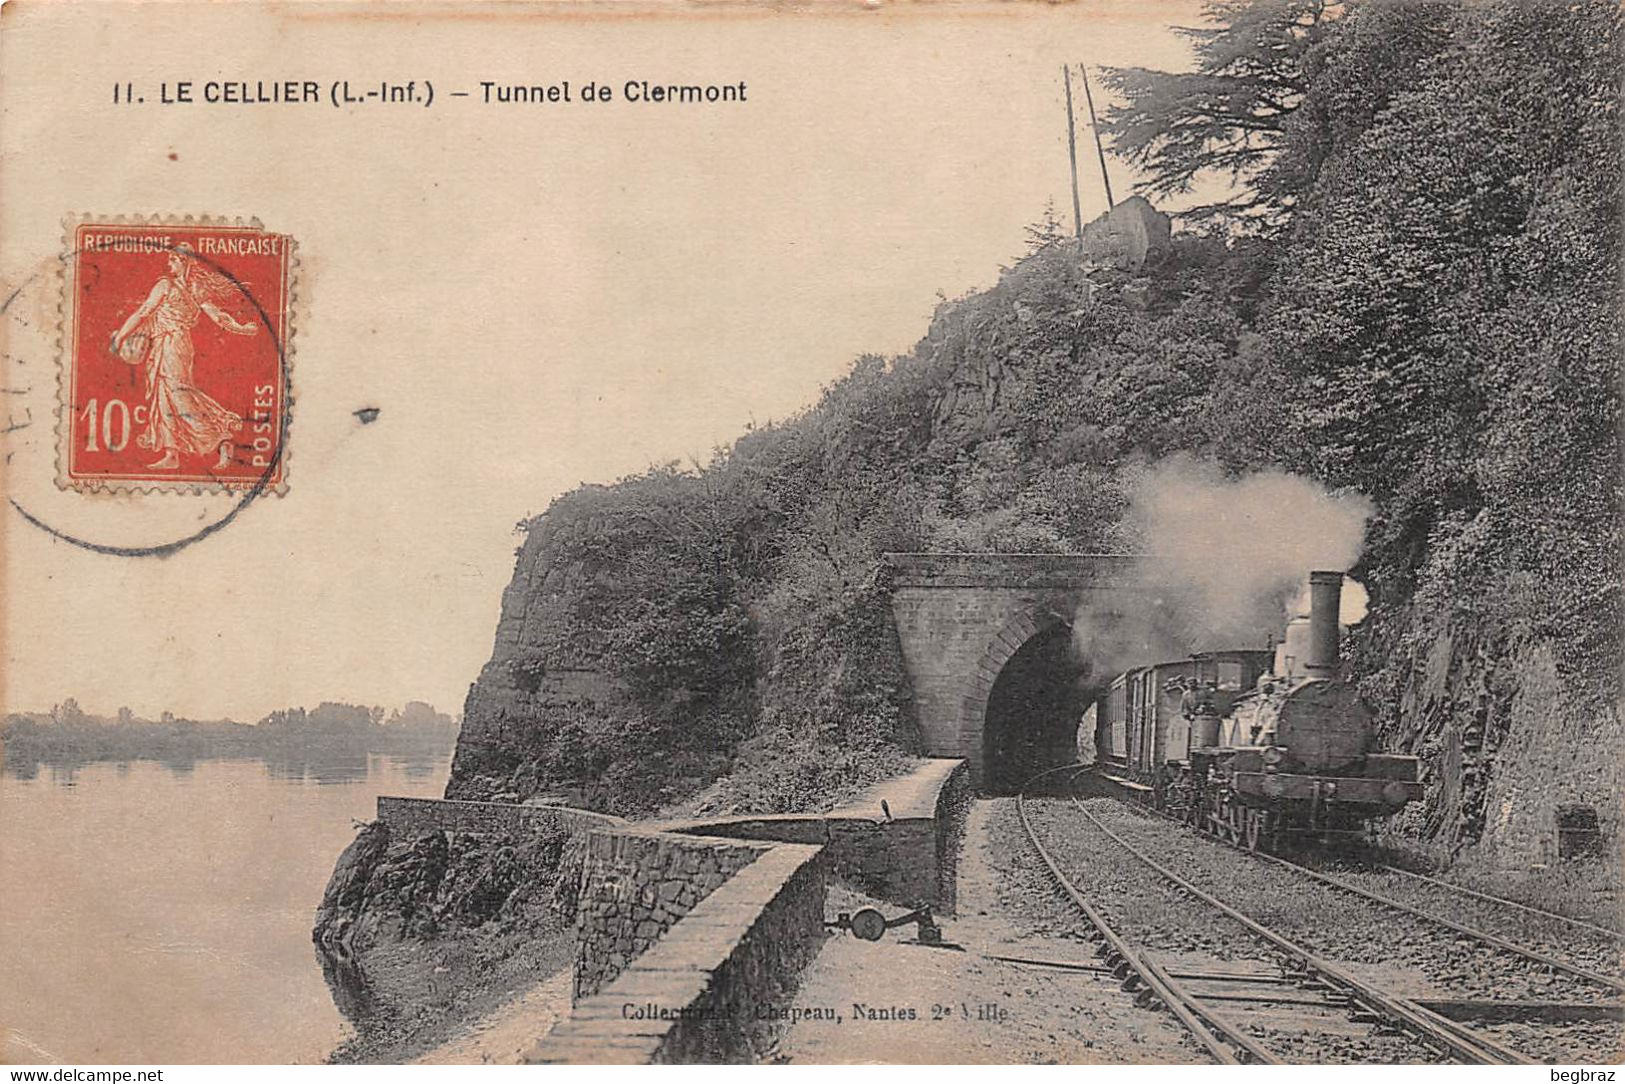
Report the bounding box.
[1079,572,1422,850]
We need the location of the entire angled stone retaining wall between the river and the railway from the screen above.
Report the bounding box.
[379,759,969,1063]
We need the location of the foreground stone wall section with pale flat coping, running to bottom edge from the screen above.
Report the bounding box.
[525,843,827,1064]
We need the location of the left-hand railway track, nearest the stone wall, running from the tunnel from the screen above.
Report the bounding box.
[1016,770,1531,1064]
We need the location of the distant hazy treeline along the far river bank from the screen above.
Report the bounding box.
[0,697,460,762]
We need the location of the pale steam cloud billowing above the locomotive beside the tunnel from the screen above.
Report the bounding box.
[1073,457,1372,679]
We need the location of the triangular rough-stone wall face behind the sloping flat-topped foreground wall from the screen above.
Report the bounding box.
[574,829,772,999]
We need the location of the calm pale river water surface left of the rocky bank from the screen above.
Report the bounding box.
[0,752,450,1064]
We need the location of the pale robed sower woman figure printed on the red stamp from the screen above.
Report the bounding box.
[111,245,260,470]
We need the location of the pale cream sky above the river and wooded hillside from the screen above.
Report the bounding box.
[0,2,1222,722]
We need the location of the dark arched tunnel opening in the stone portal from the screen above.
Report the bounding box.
[982,624,1097,795]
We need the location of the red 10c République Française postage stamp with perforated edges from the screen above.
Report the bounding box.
[57,219,293,492]
